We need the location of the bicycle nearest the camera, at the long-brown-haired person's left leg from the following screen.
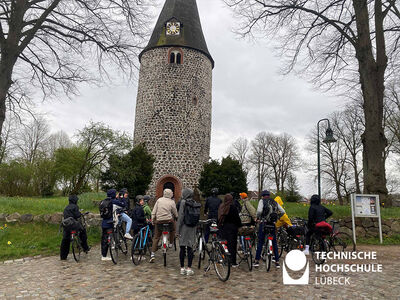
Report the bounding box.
[204,222,231,281]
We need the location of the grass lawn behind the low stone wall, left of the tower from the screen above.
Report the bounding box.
[0,193,106,215]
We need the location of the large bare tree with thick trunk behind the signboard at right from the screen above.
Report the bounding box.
[225,0,400,204]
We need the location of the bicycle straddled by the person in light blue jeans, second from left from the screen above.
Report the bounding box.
[107,209,128,264]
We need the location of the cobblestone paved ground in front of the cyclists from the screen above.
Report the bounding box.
[0,246,400,299]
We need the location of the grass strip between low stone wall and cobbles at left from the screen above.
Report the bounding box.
[0,223,101,261]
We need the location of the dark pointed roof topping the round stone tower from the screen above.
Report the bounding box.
[139,0,214,67]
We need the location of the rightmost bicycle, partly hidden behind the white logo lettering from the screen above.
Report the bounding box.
[310,221,356,265]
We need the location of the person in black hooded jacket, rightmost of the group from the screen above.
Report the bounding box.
[304,195,333,255]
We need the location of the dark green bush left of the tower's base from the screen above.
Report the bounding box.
[101,144,155,195]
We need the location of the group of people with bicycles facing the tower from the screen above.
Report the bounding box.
[60,188,332,275]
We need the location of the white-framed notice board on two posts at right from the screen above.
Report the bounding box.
[351,194,383,244]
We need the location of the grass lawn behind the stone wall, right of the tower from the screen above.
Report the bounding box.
[252,202,400,220]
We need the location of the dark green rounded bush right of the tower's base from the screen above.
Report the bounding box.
[199,156,247,195]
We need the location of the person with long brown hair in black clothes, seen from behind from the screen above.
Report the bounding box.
[218,194,242,267]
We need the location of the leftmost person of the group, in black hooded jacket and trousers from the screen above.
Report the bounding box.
[60,195,89,260]
